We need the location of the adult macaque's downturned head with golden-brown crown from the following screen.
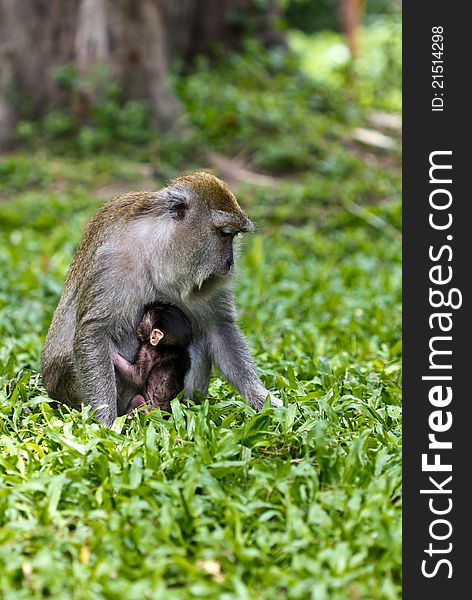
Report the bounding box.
[163,172,254,292]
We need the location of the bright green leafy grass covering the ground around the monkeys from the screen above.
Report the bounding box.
[0,18,401,600]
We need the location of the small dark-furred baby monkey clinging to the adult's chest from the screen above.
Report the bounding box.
[113,304,192,413]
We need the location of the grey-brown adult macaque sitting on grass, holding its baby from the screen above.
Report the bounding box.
[42,172,281,427]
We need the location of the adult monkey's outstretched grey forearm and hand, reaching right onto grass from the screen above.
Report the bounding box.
[209,321,282,410]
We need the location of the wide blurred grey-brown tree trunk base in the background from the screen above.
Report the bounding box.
[0,0,283,147]
